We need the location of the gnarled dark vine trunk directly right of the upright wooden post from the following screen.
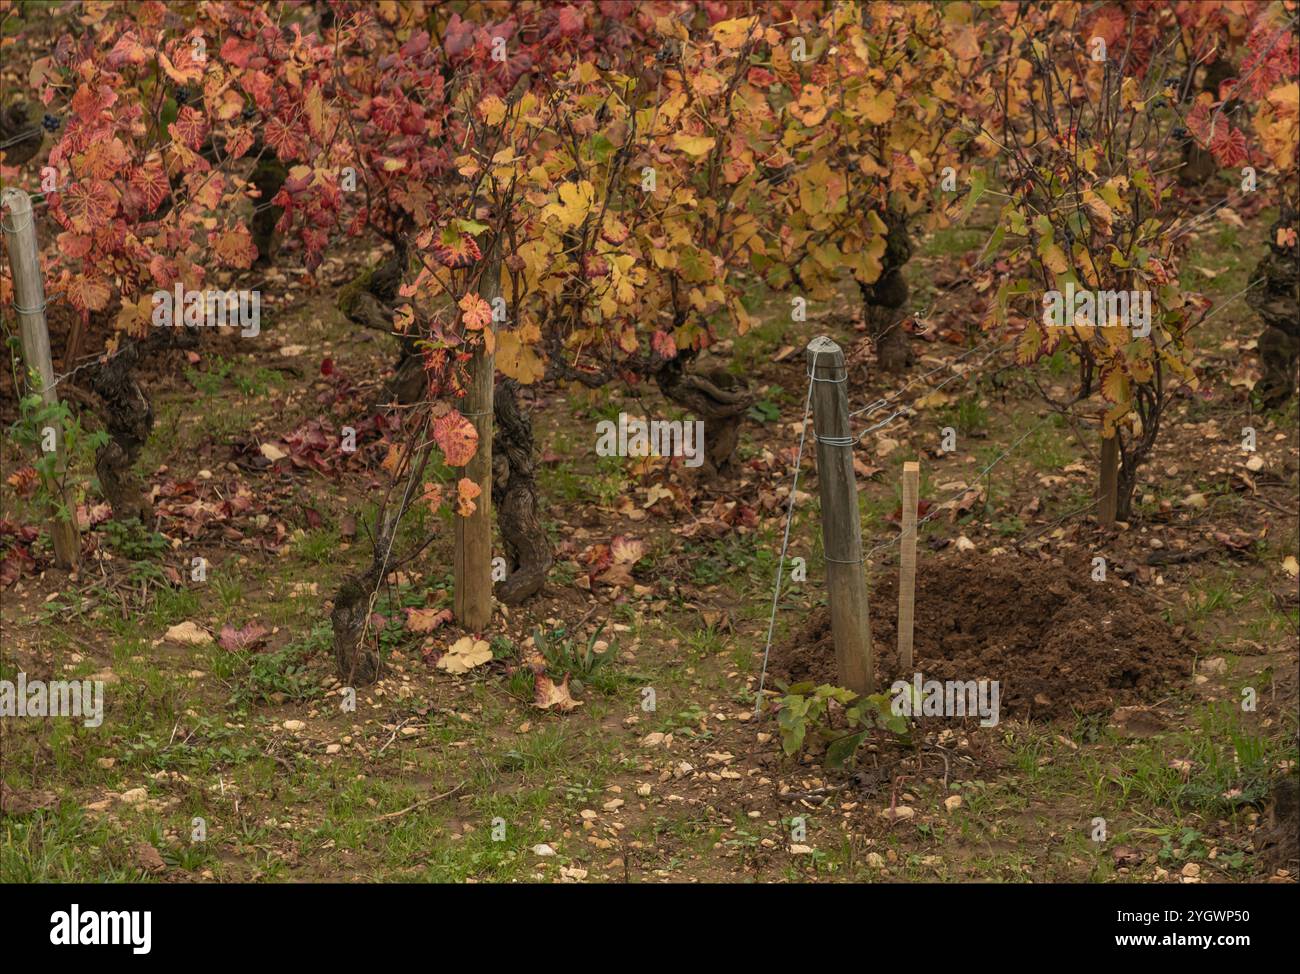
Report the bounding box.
[491,378,555,605]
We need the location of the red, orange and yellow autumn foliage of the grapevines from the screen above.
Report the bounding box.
[5,0,1297,501]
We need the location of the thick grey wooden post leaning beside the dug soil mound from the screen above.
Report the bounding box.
[805,336,876,693]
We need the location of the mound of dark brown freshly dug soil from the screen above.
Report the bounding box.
[768,555,1192,720]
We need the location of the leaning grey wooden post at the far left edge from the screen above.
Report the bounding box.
[0,187,81,570]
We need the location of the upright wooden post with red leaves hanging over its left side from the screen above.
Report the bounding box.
[455,260,501,632]
